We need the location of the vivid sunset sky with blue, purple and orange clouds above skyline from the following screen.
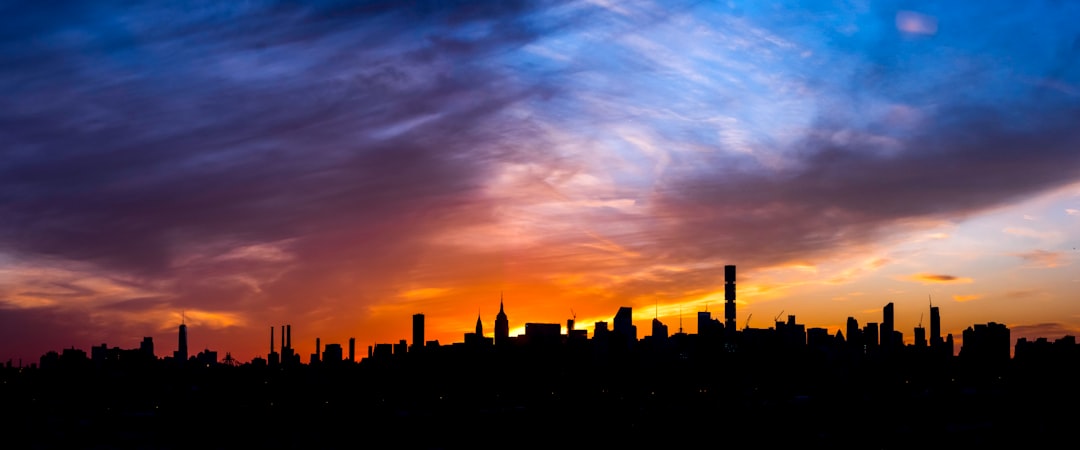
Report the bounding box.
[0,0,1080,364]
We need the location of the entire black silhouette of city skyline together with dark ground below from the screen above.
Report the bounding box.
[8,267,1080,448]
